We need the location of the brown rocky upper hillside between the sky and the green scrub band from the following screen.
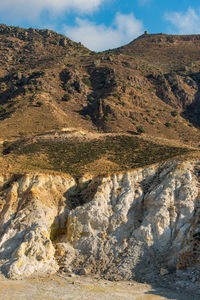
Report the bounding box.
[0,25,200,146]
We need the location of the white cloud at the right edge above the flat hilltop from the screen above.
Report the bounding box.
[165,8,200,34]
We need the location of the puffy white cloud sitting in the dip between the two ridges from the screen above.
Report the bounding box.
[65,13,144,51]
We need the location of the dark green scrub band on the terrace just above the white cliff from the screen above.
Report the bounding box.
[4,136,189,177]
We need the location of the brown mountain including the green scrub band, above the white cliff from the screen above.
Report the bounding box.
[0,25,200,176]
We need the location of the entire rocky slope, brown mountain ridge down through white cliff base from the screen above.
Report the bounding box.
[0,25,200,299]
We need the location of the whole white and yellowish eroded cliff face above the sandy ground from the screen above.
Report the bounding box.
[0,161,200,279]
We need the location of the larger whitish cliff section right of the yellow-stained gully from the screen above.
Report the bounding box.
[63,162,198,279]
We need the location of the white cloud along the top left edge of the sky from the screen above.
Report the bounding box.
[0,0,105,21]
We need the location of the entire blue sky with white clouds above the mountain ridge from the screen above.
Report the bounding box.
[0,0,200,51]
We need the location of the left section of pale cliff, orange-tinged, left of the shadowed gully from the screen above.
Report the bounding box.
[0,175,75,279]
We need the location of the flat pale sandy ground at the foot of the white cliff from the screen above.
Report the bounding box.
[0,275,199,300]
